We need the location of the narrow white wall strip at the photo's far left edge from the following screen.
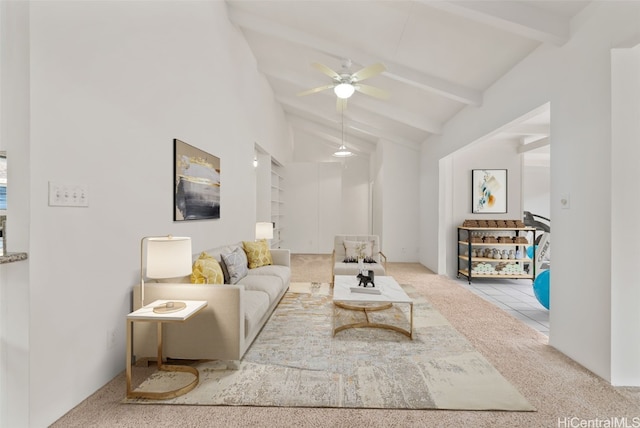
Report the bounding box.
[0,2,31,427]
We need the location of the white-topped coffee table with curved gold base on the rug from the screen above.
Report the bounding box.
[333,275,413,339]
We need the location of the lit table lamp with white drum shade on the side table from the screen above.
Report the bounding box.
[140,235,192,313]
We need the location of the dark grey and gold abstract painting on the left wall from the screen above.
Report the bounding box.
[173,139,220,221]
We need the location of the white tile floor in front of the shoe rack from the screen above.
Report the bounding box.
[457,277,549,336]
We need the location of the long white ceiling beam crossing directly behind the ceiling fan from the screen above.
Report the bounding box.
[227,4,482,106]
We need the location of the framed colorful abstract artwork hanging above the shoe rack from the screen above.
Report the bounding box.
[471,169,507,214]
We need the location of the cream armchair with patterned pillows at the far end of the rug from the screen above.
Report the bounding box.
[331,235,387,287]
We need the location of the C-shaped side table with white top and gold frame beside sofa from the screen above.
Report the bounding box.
[126,300,207,400]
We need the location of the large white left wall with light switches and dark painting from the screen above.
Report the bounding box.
[2,1,291,426]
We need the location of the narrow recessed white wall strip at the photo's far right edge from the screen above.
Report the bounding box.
[611,43,640,385]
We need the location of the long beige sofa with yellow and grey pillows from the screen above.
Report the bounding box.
[133,243,291,360]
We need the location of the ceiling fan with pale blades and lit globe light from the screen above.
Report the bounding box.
[298,59,389,110]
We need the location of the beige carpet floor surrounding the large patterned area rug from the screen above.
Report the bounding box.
[52,255,640,428]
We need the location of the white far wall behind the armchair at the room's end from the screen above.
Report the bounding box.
[285,141,420,262]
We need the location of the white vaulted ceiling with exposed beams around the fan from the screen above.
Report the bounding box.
[227,0,589,160]
